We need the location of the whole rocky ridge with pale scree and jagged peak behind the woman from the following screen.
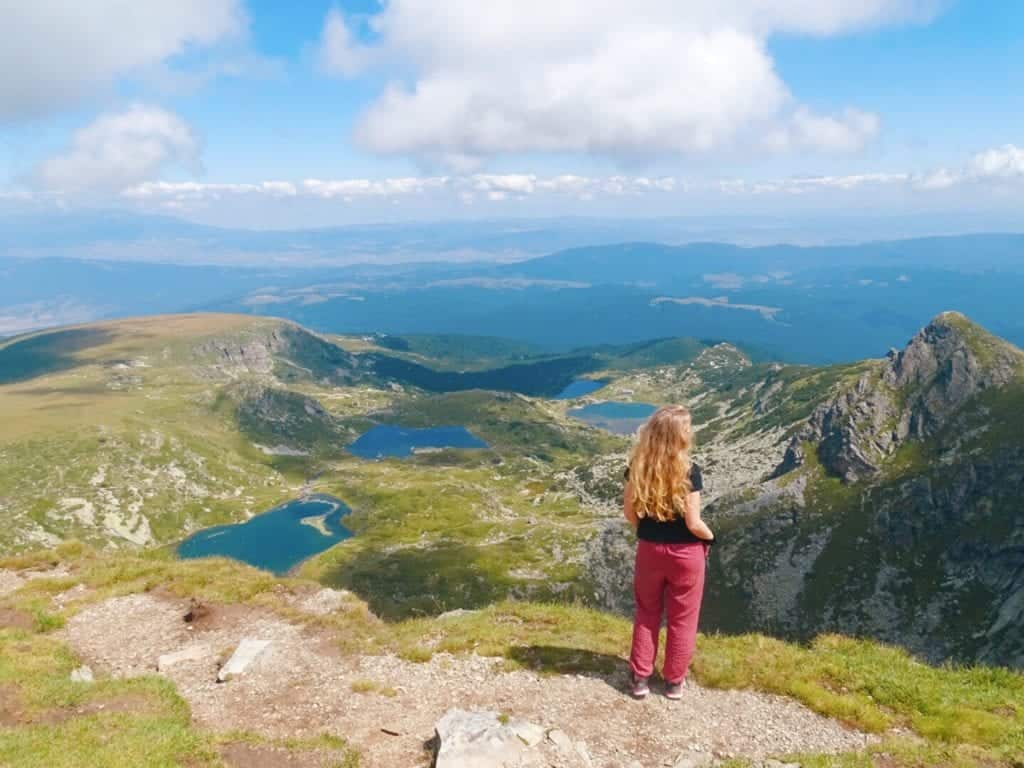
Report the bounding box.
[570,312,1024,667]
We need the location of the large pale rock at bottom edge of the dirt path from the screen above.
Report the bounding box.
[434,710,532,768]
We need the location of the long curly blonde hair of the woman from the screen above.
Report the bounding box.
[630,406,693,522]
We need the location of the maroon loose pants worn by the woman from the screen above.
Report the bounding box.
[630,540,708,683]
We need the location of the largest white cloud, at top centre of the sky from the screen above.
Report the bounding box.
[321,0,936,163]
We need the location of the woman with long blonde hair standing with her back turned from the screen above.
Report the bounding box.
[624,406,715,699]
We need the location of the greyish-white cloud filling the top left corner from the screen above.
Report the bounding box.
[0,0,246,122]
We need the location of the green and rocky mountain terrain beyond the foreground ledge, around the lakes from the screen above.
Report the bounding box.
[0,313,1024,666]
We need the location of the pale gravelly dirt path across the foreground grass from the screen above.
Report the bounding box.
[63,595,866,768]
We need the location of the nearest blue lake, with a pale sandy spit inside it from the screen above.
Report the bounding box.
[178,496,352,574]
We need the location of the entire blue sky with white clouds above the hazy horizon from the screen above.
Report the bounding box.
[0,0,1024,226]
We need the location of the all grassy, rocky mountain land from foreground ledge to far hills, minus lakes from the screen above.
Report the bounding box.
[0,313,1024,768]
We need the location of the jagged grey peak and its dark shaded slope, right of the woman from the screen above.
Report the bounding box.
[705,313,1024,667]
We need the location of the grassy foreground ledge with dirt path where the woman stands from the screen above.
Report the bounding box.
[0,544,1024,768]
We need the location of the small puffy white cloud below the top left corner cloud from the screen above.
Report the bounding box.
[38,104,200,193]
